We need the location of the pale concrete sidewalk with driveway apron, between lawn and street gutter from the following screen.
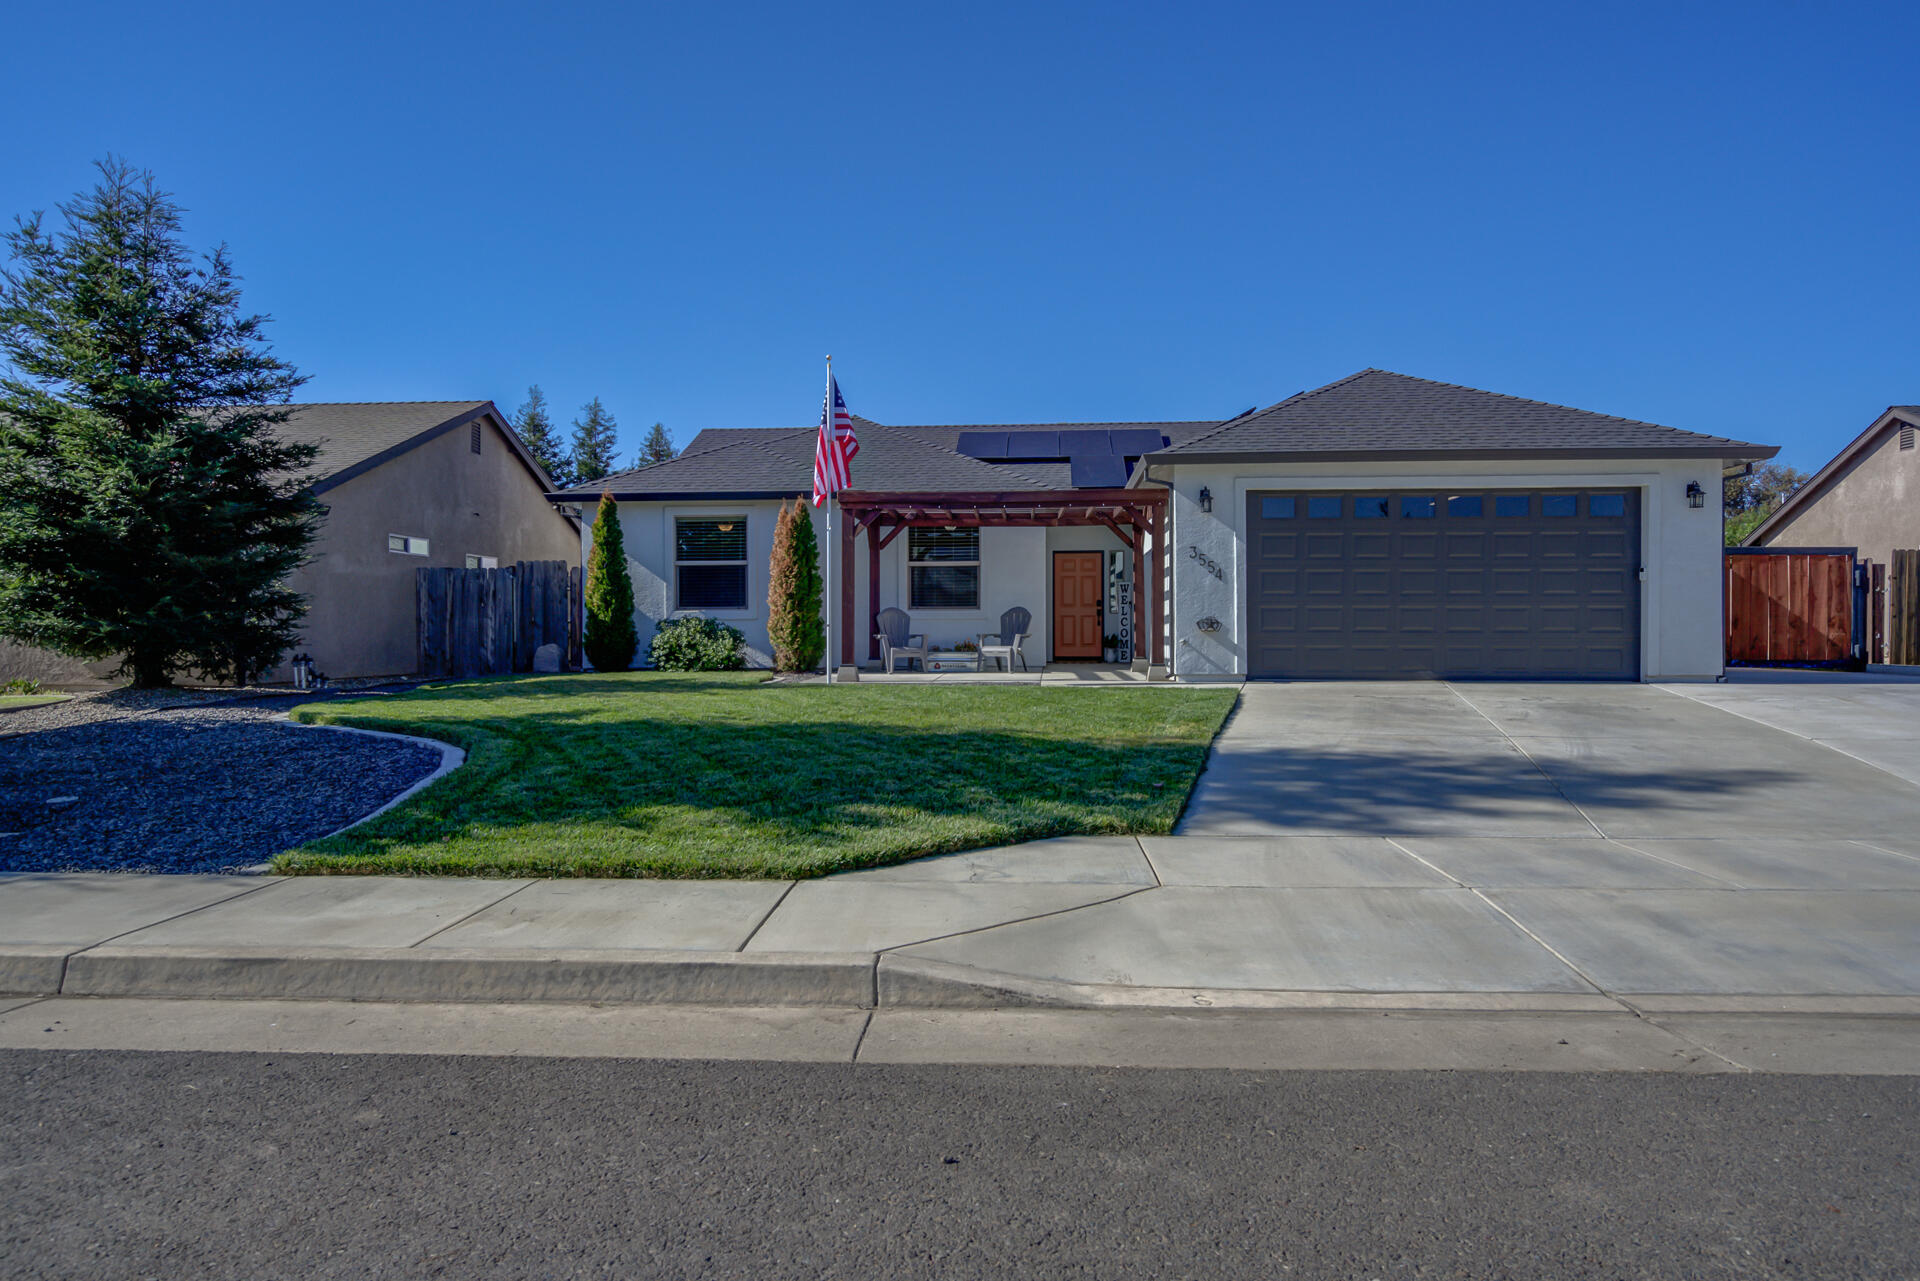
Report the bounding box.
[0,835,1920,1014]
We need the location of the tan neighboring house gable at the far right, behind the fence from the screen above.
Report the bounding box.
[1745,405,1920,565]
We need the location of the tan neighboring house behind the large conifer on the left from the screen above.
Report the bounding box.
[0,399,580,684]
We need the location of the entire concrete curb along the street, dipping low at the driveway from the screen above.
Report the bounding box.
[11,943,1920,1018]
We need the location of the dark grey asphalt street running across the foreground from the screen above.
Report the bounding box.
[0,1051,1920,1281]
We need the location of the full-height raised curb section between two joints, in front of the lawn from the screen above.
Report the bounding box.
[60,947,874,1008]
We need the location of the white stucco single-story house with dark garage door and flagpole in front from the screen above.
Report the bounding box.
[551,369,1776,680]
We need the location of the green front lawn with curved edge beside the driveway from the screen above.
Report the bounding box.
[275,672,1235,878]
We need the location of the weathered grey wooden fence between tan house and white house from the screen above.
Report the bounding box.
[426,561,580,676]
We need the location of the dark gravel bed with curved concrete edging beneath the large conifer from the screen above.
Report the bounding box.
[0,689,440,872]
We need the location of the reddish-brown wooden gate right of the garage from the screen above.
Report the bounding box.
[1726,547,1855,665]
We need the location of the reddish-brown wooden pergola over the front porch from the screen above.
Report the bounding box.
[835,490,1167,668]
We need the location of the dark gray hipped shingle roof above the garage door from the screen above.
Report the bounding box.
[1154,369,1778,463]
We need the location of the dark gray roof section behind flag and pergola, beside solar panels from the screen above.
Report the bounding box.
[551,417,1215,501]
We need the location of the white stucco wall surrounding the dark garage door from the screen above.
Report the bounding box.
[1152,459,1724,680]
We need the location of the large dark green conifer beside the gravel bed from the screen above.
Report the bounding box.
[0,157,321,688]
